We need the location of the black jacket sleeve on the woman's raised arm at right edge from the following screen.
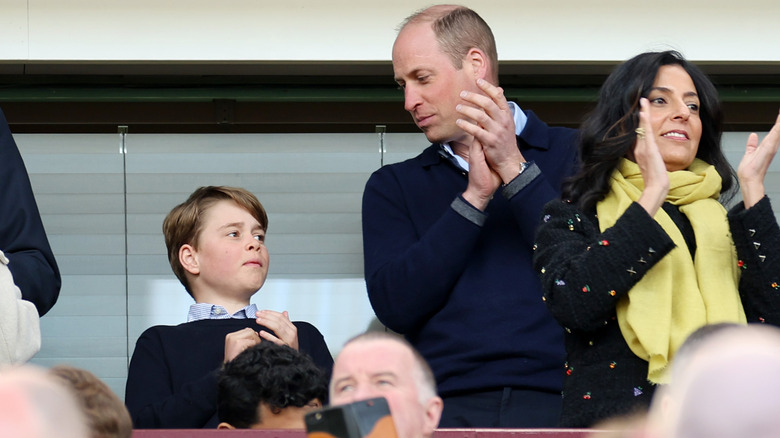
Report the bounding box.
[729,196,780,325]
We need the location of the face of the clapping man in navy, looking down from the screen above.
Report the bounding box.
[393,23,479,143]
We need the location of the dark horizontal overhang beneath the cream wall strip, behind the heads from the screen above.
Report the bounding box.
[0,61,780,133]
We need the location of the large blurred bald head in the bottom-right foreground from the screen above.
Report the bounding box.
[650,324,780,438]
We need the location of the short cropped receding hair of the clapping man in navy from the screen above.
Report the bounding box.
[399,5,498,82]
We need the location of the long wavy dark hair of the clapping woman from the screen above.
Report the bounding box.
[562,51,735,210]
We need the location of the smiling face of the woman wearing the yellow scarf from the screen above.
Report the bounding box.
[647,65,701,172]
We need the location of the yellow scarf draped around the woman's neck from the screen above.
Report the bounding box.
[596,158,746,383]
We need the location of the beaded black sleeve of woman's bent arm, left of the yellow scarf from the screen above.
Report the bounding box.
[534,200,674,331]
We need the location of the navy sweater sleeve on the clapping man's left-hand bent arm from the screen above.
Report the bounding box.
[363,168,482,333]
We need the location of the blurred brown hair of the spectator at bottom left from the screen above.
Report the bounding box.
[49,365,133,438]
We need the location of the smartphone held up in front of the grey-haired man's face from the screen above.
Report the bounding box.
[304,397,397,438]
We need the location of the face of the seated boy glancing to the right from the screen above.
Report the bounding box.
[182,200,269,300]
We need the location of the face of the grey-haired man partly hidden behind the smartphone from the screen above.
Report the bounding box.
[330,339,441,438]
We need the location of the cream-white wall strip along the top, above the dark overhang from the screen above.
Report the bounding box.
[10,0,780,63]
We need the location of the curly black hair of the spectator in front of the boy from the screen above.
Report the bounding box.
[217,341,328,429]
